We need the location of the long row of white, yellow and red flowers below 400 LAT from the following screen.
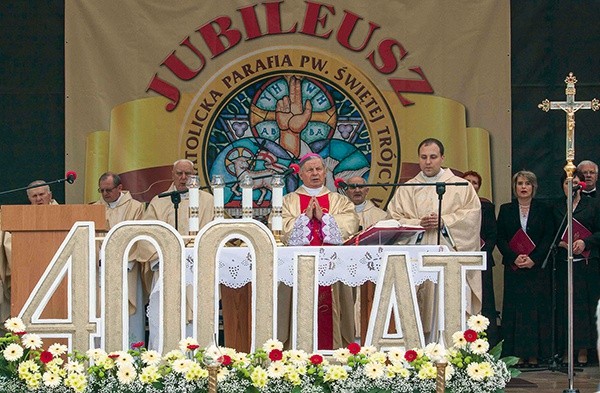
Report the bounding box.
[0,316,518,393]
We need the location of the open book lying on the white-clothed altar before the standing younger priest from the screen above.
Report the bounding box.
[344,220,425,246]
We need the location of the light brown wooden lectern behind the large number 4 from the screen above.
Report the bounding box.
[2,205,107,319]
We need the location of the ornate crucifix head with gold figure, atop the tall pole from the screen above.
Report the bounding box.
[538,72,600,178]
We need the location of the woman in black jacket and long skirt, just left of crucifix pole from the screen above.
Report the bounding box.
[498,171,554,366]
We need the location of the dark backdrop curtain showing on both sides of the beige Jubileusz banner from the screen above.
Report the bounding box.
[0,0,600,204]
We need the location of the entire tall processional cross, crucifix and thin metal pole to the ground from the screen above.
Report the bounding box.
[538,72,600,393]
